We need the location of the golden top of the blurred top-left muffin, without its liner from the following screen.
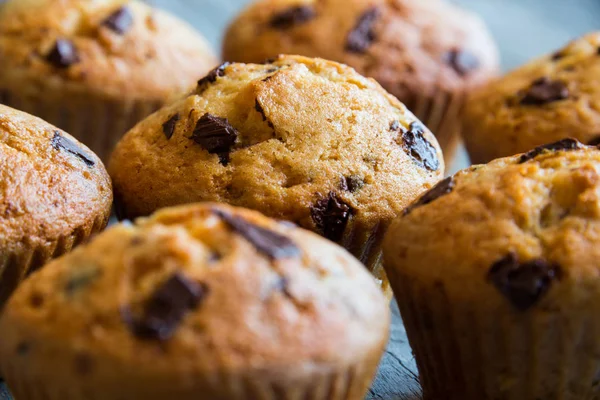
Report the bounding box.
[0,0,217,100]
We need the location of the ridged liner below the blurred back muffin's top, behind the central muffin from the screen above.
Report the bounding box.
[404,91,466,166]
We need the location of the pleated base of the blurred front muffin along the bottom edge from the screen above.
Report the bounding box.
[3,356,383,400]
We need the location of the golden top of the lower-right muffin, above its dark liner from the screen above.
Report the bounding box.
[384,139,600,311]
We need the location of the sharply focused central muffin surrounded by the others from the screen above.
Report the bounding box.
[109,56,444,296]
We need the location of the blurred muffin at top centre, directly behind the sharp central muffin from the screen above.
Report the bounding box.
[223,0,499,164]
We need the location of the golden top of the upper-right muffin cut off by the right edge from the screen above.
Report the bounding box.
[464,32,600,162]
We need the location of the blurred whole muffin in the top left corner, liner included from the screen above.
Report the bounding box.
[0,0,218,158]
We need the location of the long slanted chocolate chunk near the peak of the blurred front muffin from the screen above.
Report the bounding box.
[215,210,300,260]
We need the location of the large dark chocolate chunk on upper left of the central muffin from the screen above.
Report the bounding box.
[190,113,238,164]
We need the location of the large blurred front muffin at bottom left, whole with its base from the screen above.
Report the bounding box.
[0,204,390,400]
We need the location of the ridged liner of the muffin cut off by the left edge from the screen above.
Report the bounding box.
[0,213,110,310]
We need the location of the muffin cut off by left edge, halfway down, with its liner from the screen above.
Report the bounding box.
[0,105,112,310]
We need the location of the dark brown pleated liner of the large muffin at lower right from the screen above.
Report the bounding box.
[388,270,600,400]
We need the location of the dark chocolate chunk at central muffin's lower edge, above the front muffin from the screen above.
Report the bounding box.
[310,192,354,242]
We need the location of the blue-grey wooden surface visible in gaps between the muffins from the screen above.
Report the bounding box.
[0,0,600,400]
